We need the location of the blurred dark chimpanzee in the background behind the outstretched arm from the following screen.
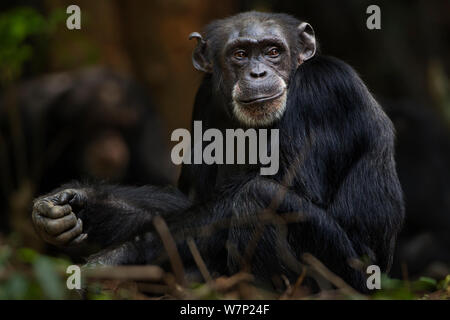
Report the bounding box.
[0,67,174,235]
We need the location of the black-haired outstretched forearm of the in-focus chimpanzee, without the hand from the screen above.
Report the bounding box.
[72,185,190,247]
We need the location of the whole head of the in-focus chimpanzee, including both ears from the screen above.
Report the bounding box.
[191,13,315,127]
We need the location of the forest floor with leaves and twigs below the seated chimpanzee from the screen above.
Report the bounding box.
[0,238,450,300]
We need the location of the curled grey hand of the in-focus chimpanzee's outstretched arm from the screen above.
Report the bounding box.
[32,189,87,246]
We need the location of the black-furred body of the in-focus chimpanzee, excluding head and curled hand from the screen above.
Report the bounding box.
[37,12,404,291]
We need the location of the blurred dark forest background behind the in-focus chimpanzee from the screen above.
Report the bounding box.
[0,0,450,277]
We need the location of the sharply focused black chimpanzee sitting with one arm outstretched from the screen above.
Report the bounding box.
[32,12,404,291]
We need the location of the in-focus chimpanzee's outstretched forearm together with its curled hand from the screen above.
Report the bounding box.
[32,183,190,248]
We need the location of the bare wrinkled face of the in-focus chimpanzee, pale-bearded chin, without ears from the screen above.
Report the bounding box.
[221,24,292,126]
